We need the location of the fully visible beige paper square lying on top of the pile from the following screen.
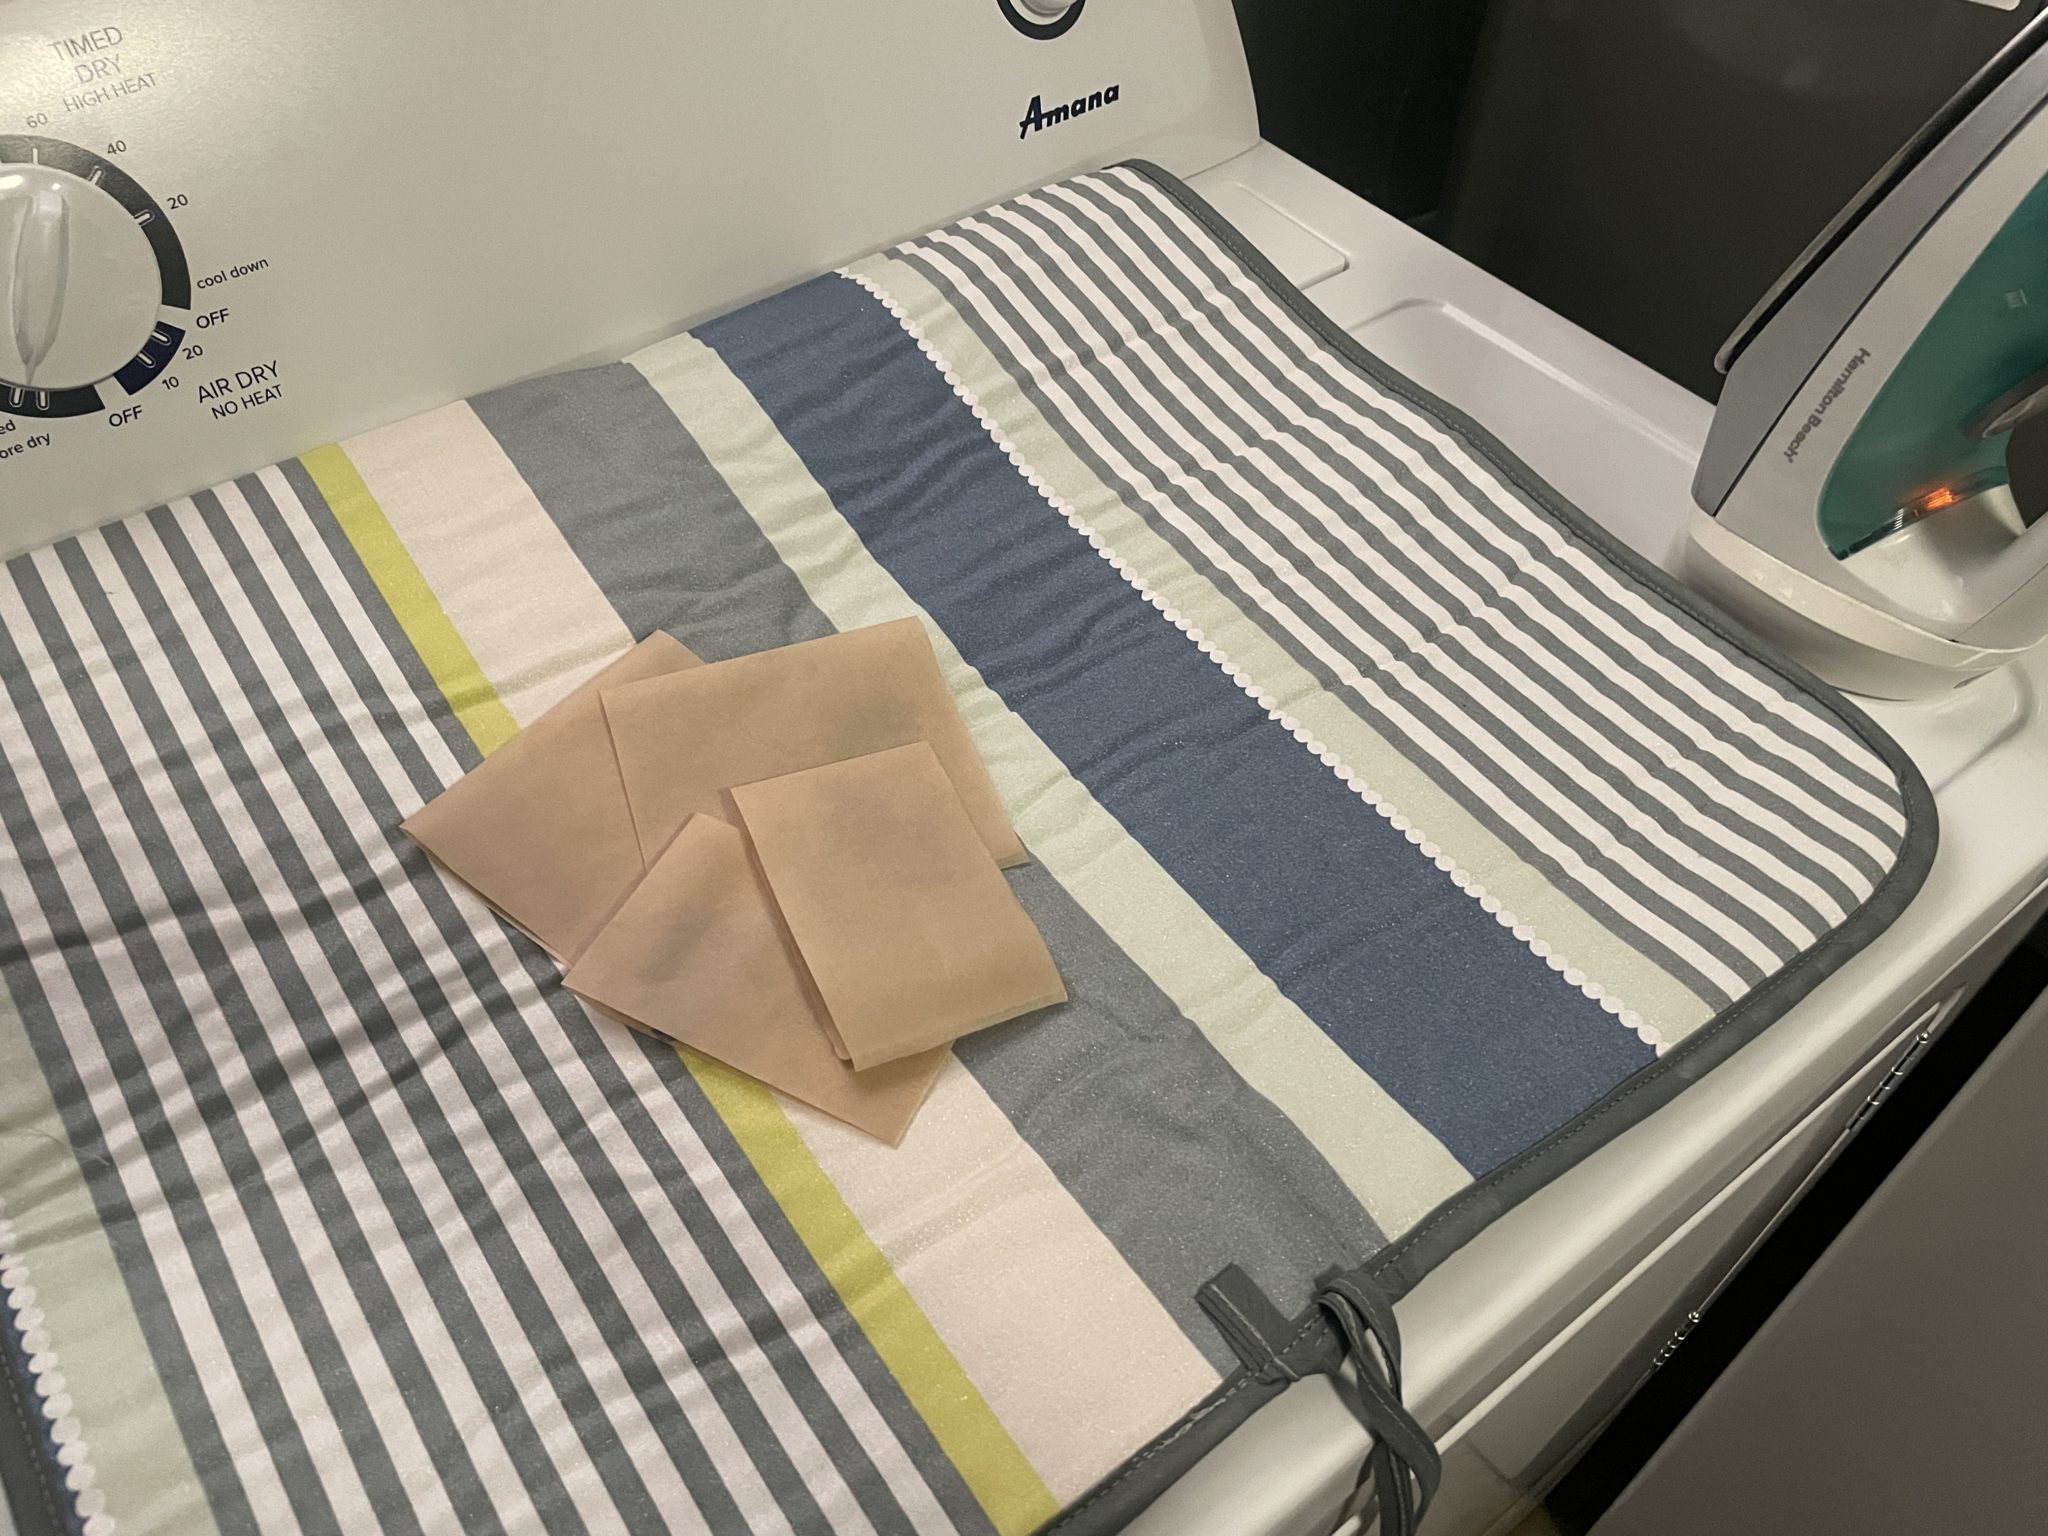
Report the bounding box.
[733,741,1067,1071]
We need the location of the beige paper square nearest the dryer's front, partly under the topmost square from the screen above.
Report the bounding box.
[563,815,942,1145]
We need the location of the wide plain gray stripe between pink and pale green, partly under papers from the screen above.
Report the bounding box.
[471,358,1382,1366]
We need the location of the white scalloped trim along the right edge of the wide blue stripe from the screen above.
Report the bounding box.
[840,266,1667,1055]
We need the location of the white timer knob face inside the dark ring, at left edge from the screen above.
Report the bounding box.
[0,164,164,389]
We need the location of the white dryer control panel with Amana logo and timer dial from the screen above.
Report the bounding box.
[0,0,1257,555]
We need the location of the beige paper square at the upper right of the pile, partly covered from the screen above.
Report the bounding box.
[604,618,1026,866]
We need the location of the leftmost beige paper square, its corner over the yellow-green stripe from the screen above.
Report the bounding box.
[403,631,700,961]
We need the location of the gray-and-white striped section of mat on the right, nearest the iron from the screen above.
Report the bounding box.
[893,168,1905,1006]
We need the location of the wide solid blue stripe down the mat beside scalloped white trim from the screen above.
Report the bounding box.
[698,276,1651,1174]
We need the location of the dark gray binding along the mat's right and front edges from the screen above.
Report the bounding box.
[1044,160,1939,1536]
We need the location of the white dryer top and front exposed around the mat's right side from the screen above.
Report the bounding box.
[1135,143,2048,1536]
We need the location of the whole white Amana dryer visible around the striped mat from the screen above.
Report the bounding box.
[0,0,2048,1536]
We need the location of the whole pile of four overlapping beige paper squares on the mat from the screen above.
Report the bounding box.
[406,618,1067,1143]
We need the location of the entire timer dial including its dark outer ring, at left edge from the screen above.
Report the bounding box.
[0,133,193,418]
